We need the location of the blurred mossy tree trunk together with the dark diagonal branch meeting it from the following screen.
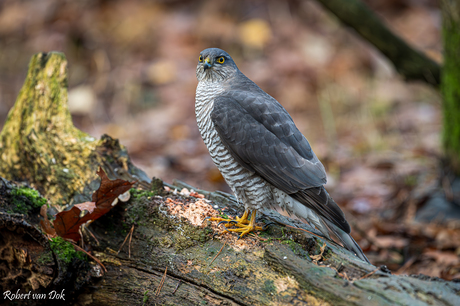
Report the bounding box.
[308,0,460,175]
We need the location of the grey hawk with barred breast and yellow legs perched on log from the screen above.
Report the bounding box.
[195,48,369,262]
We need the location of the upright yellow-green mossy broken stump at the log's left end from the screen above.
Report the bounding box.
[0,52,149,204]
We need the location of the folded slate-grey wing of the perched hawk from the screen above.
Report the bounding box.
[211,91,350,233]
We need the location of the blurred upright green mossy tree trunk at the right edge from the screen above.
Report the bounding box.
[441,0,460,175]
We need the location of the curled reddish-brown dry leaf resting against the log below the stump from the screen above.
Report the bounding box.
[54,168,135,241]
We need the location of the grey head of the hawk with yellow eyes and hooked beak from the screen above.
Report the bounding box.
[196,48,238,82]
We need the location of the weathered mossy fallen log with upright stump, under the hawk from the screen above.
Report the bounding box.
[0,53,460,305]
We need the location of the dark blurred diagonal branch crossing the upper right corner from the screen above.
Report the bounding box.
[310,0,441,87]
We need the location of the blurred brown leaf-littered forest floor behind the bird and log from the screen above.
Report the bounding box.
[0,0,460,279]
